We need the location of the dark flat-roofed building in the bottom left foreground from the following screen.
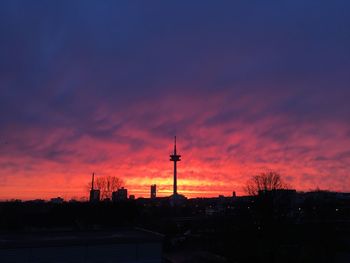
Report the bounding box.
[0,229,163,263]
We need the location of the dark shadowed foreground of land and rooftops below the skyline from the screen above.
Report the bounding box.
[0,191,350,263]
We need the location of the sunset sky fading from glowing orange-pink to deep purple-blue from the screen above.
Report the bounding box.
[0,0,350,200]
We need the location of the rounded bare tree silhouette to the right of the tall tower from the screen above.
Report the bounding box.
[244,171,288,195]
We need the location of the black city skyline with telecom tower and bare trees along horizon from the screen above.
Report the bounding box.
[2,136,347,203]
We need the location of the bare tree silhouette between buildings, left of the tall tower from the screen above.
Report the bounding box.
[88,176,124,199]
